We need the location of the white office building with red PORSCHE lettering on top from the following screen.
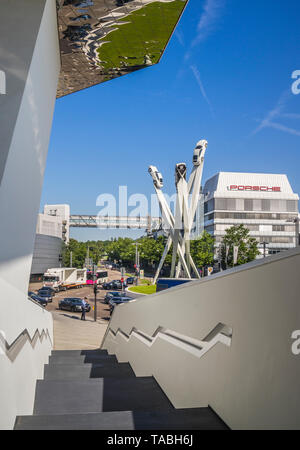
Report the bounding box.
[194,172,299,254]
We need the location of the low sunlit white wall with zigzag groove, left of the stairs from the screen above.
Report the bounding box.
[0,282,53,430]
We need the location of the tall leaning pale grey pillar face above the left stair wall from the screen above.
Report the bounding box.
[0,0,60,292]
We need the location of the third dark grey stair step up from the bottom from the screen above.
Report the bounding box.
[44,362,135,381]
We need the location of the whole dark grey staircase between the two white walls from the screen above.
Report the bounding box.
[15,350,227,430]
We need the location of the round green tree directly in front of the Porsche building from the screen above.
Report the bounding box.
[221,225,259,267]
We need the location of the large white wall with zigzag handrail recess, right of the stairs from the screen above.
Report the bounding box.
[102,248,300,429]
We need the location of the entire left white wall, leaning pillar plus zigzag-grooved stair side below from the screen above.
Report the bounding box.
[0,0,60,429]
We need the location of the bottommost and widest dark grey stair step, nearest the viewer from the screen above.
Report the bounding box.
[15,408,228,430]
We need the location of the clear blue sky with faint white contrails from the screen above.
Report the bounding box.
[41,0,300,240]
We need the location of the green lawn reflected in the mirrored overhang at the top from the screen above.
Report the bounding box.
[98,0,186,70]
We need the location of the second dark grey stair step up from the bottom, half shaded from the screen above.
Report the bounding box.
[34,377,173,414]
